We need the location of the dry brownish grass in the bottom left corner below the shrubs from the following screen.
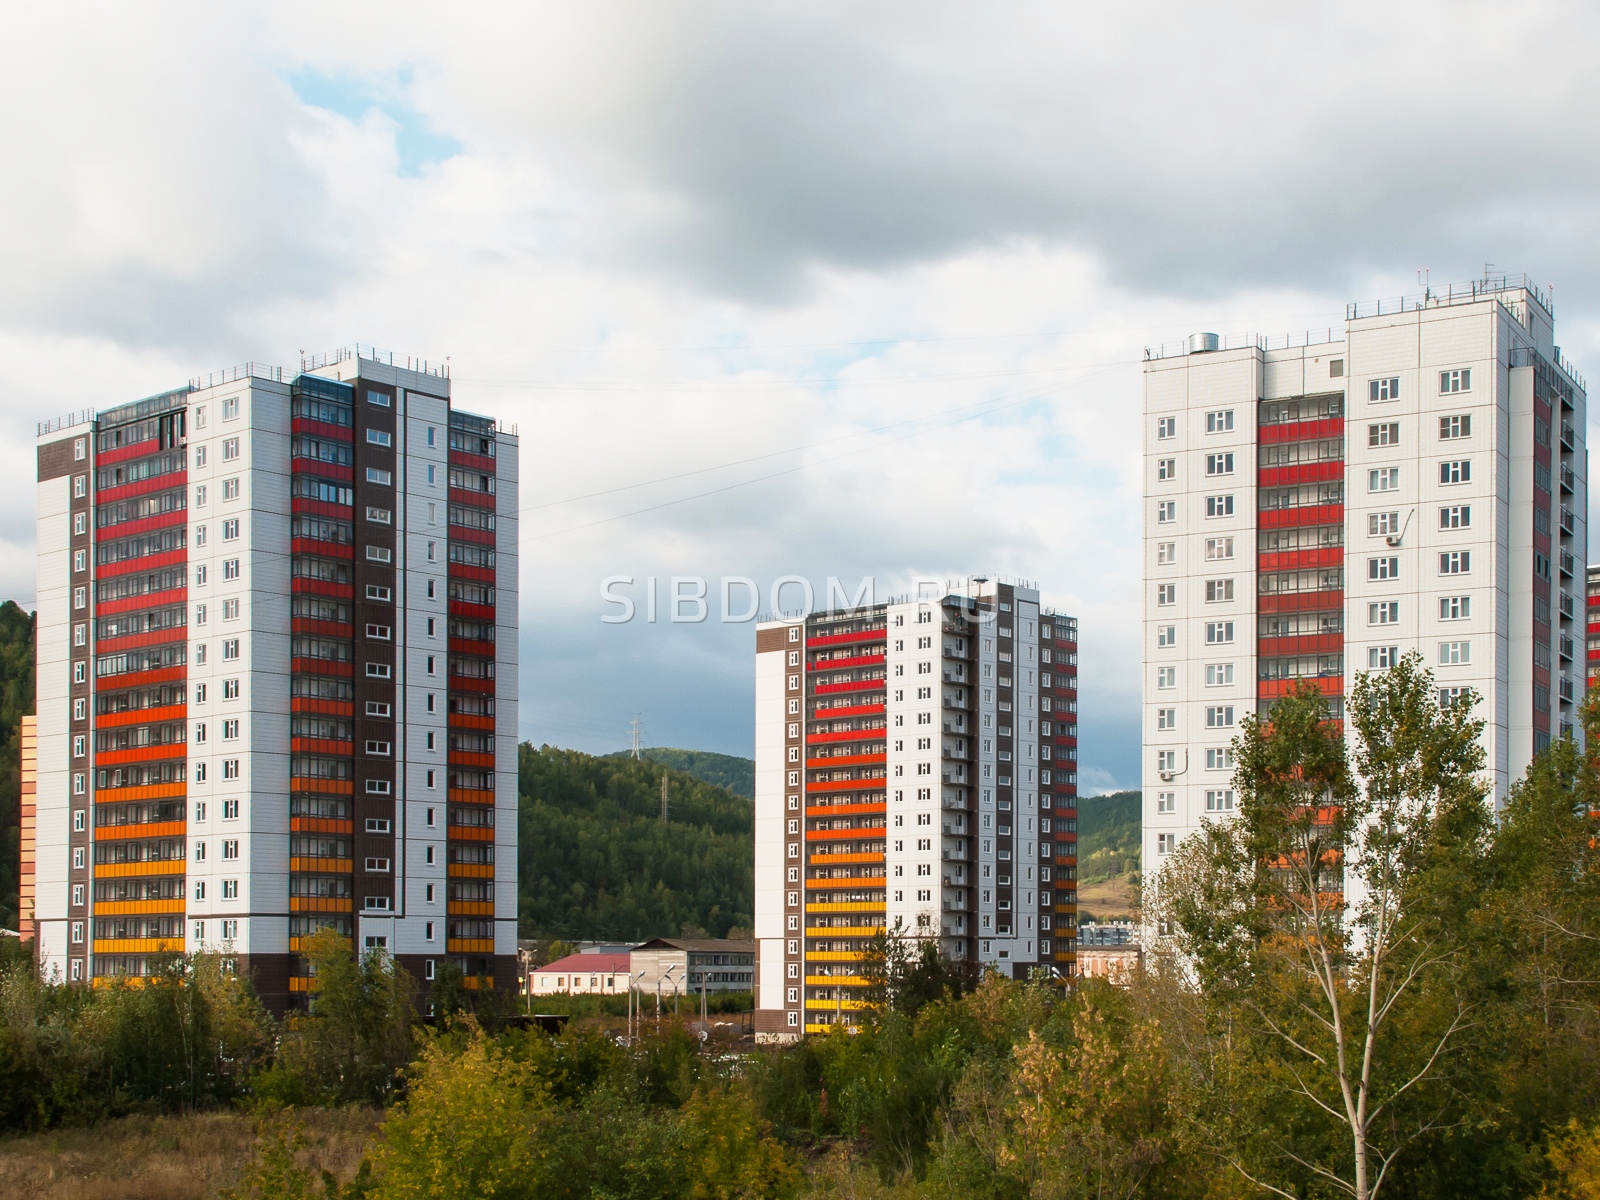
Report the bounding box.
[0,1109,382,1200]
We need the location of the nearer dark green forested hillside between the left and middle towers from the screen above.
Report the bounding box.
[517,744,755,941]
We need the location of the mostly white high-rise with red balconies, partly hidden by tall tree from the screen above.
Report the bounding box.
[1144,277,1587,874]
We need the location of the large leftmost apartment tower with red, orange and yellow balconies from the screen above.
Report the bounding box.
[35,347,517,1010]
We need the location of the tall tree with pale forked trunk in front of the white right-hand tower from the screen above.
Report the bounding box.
[1157,654,1488,1200]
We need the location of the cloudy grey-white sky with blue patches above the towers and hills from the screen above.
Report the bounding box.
[0,0,1600,790]
